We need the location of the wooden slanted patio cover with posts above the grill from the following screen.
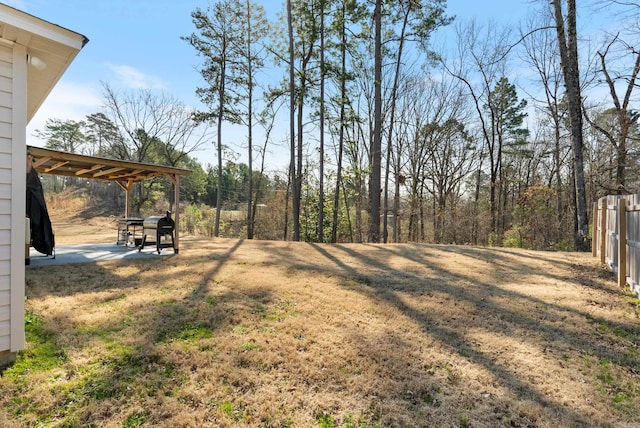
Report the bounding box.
[27,146,191,254]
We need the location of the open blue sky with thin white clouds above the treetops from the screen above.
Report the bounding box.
[5,0,531,163]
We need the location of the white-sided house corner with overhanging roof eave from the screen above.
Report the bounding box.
[0,9,88,360]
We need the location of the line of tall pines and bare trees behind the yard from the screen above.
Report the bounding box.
[33,0,640,249]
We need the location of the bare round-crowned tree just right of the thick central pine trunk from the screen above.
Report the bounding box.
[396,75,475,242]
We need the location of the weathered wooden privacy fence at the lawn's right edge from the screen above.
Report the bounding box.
[591,194,640,296]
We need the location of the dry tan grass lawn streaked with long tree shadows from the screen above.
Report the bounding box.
[0,238,640,427]
